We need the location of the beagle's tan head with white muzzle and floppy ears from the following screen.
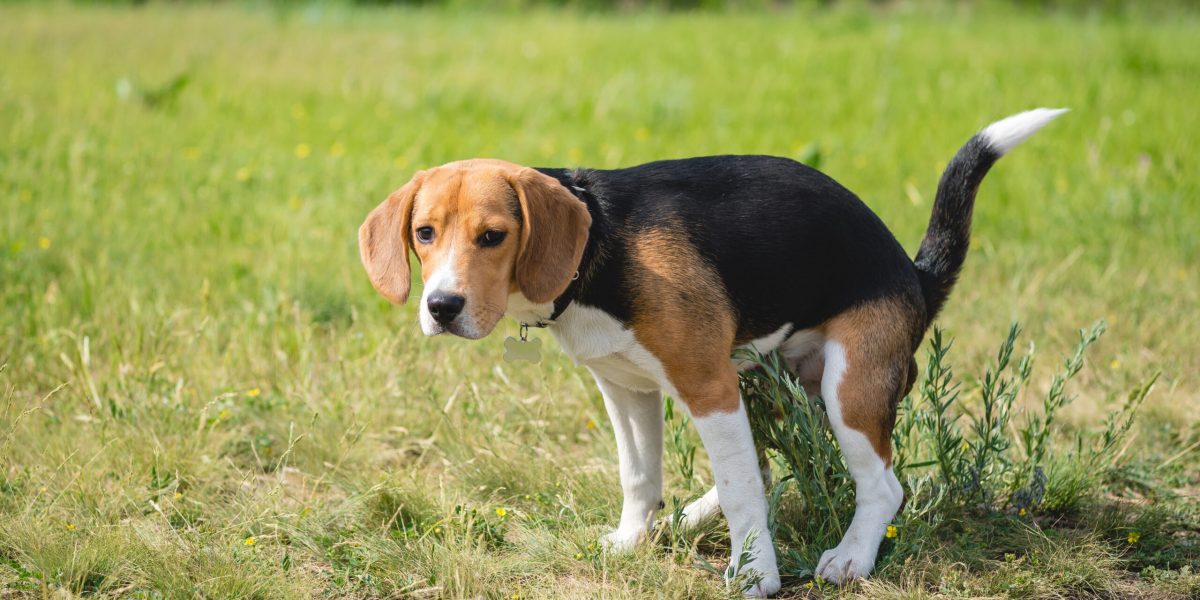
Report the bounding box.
[359,160,592,340]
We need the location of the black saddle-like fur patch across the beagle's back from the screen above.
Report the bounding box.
[539,155,924,343]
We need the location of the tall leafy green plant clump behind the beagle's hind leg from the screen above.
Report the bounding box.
[742,322,1154,576]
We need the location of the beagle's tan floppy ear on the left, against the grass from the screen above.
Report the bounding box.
[359,172,425,304]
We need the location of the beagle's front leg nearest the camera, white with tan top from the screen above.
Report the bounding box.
[683,373,780,598]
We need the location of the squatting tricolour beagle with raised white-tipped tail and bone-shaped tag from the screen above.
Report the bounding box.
[359,108,1064,596]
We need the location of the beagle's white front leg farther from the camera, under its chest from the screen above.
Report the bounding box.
[592,372,662,552]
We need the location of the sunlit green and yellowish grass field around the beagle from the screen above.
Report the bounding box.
[0,5,1200,598]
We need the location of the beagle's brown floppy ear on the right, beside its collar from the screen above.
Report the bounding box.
[509,168,592,302]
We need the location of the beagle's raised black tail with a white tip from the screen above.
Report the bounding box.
[914,108,1067,322]
